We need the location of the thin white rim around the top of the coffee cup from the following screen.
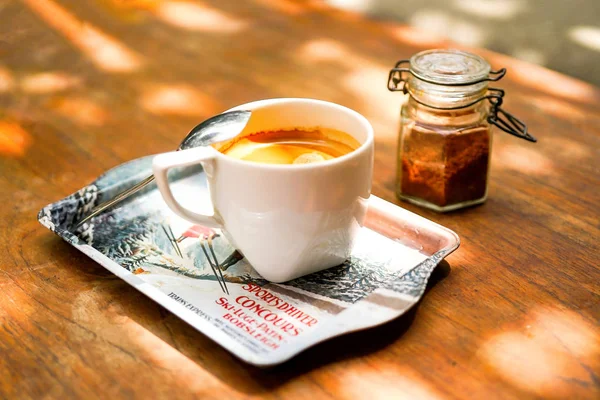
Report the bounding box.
[210,97,375,171]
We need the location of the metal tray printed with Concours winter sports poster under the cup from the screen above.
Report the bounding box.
[38,157,459,366]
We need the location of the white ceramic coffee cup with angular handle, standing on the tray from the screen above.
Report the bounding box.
[152,98,373,282]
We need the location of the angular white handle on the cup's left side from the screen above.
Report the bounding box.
[152,147,223,229]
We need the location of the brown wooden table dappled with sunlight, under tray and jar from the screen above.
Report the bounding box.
[0,0,600,399]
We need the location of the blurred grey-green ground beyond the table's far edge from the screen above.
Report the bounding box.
[325,0,600,86]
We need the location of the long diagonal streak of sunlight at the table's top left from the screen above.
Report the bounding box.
[23,0,142,72]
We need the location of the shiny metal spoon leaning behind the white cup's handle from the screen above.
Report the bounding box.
[75,110,251,228]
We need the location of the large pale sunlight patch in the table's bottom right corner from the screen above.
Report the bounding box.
[477,308,600,398]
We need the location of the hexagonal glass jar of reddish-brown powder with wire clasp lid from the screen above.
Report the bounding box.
[388,50,535,212]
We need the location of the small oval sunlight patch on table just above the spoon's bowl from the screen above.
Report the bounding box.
[140,84,222,117]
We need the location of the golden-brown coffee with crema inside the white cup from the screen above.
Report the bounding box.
[217,129,360,164]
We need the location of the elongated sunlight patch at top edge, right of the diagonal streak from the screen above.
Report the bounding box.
[156,1,248,33]
